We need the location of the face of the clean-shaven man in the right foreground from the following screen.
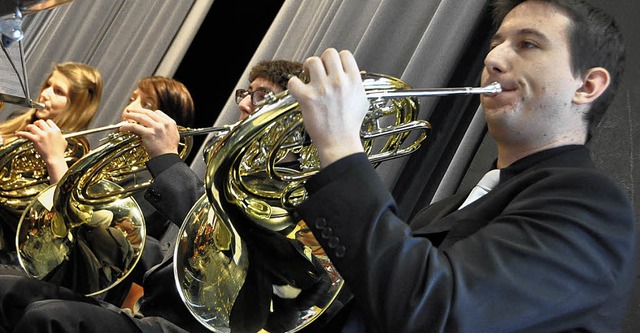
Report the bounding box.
[481,1,582,141]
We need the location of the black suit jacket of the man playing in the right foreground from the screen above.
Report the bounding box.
[298,146,636,332]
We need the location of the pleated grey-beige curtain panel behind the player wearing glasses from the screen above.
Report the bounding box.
[192,0,486,197]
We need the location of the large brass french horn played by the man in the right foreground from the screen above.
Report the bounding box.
[174,72,500,332]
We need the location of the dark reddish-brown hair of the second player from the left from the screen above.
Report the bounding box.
[138,76,195,127]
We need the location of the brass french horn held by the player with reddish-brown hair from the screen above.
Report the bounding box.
[16,128,193,296]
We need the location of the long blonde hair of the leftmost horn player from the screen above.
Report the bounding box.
[0,62,102,142]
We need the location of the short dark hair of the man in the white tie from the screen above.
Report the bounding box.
[493,0,625,141]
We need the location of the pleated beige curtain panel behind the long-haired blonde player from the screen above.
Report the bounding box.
[2,0,213,145]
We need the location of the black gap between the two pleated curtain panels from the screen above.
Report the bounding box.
[174,0,284,163]
